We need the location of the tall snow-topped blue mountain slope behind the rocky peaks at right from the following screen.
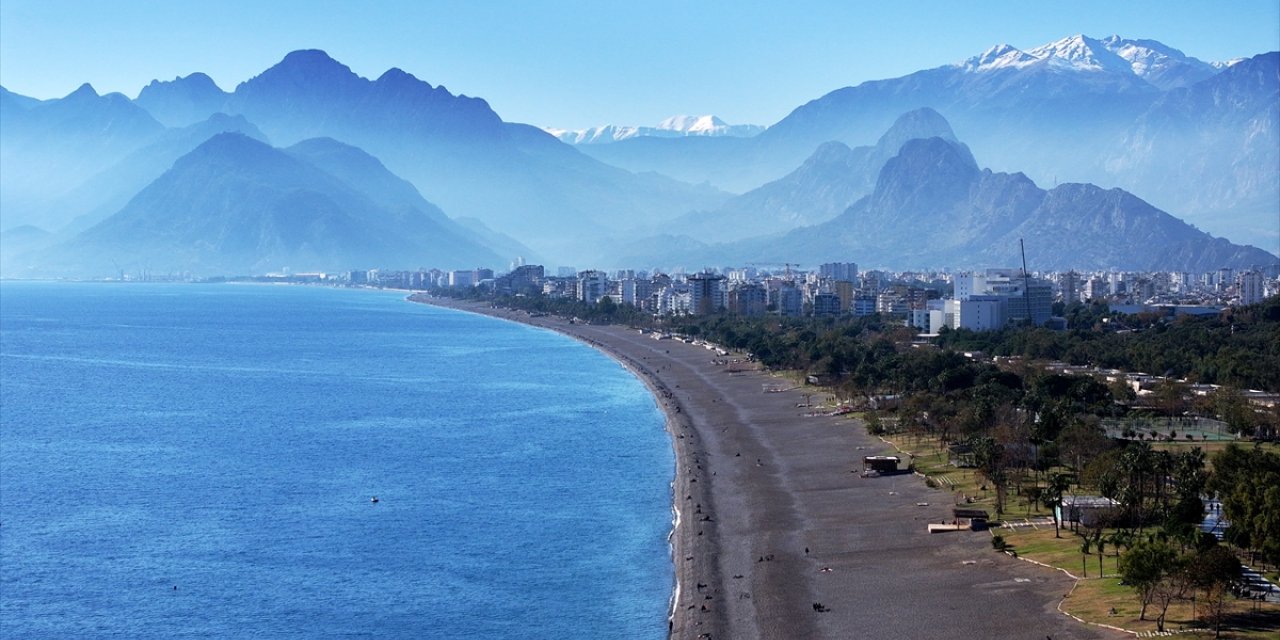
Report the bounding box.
[582,36,1160,191]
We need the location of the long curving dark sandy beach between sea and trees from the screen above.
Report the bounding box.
[409,298,1128,640]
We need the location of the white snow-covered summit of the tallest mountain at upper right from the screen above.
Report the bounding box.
[955,35,1239,91]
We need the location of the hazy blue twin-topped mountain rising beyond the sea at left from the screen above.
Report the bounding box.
[28,133,502,275]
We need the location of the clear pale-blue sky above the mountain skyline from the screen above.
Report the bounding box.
[0,0,1280,128]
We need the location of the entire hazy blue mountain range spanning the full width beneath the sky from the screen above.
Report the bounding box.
[0,36,1280,276]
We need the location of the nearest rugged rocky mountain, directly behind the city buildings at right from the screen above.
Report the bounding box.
[614,137,1277,273]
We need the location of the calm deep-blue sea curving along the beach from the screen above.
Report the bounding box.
[0,282,675,639]
